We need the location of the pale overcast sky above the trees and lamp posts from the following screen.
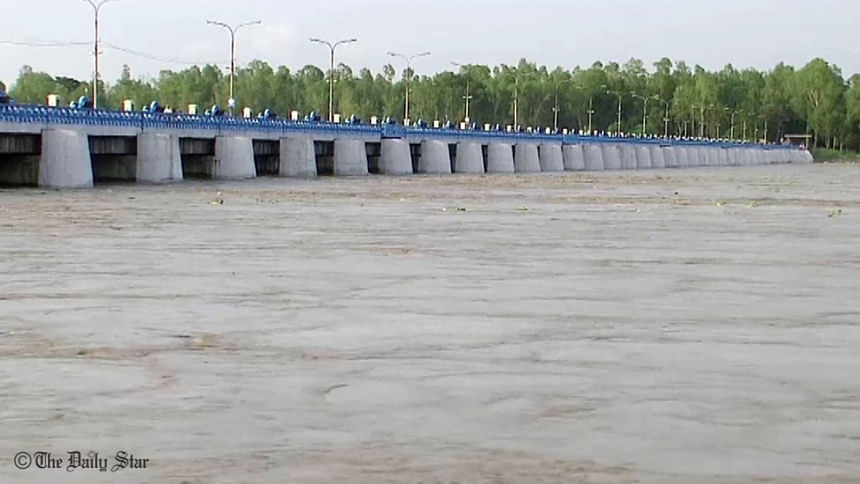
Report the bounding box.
[0,0,860,84]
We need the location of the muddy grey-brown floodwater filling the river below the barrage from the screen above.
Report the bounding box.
[0,165,860,483]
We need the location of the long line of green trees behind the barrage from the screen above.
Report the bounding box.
[10,58,860,149]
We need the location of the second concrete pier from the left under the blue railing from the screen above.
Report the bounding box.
[136,133,183,183]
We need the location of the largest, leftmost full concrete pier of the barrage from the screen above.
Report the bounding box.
[39,129,93,188]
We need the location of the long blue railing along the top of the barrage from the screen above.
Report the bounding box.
[0,105,798,150]
